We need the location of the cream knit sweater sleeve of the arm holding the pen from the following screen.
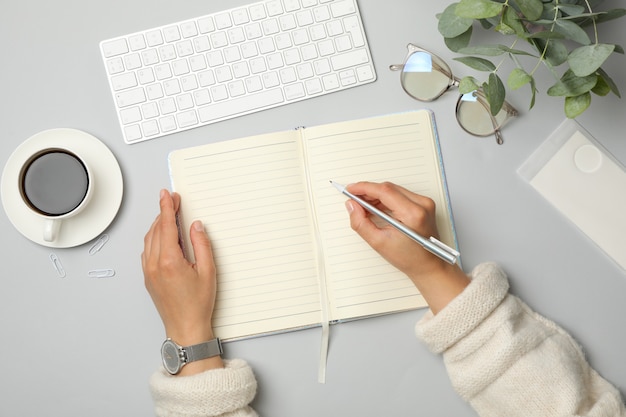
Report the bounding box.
[416,263,626,417]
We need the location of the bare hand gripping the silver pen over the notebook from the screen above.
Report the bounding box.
[334,182,469,313]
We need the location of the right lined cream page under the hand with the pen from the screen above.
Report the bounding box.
[305,110,448,319]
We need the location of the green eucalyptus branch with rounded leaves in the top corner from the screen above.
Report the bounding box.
[438,0,626,117]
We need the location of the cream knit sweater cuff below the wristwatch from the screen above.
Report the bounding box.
[150,359,257,417]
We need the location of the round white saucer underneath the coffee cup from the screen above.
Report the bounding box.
[1,129,124,248]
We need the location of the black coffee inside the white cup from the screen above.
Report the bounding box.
[20,150,89,216]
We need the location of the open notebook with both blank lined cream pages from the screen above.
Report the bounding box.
[169,110,456,340]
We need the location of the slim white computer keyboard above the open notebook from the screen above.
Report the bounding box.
[100,0,376,143]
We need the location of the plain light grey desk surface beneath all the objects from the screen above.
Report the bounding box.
[0,0,626,417]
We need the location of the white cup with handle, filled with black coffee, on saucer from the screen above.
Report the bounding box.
[19,148,94,242]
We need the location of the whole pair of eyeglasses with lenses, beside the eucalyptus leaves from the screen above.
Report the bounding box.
[389,44,517,145]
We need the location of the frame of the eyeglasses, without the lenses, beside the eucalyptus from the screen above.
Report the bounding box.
[389,43,519,145]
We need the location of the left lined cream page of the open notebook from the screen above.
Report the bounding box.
[170,131,321,339]
